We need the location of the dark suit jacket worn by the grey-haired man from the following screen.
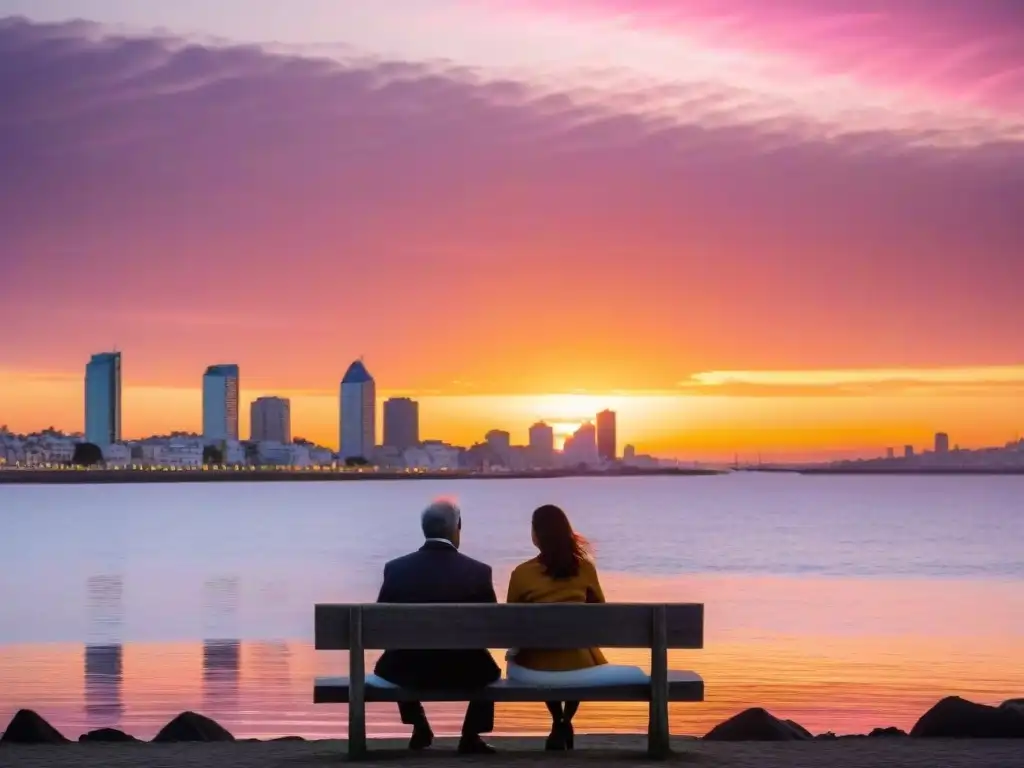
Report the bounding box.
[374,541,502,689]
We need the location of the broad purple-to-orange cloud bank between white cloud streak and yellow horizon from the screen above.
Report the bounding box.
[0,22,1024,397]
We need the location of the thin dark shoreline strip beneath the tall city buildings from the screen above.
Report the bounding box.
[0,468,728,485]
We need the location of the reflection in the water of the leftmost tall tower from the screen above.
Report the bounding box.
[84,575,124,728]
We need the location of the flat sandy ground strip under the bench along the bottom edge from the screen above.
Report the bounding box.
[0,735,1024,768]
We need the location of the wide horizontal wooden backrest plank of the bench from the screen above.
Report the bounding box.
[315,603,703,650]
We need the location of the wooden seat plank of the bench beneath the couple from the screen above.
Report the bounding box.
[313,671,703,703]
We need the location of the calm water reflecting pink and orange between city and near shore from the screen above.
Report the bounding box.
[0,474,1024,737]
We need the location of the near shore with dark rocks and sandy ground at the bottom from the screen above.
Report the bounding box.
[0,696,1024,768]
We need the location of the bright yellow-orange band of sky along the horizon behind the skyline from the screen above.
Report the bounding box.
[0,369,1024,460]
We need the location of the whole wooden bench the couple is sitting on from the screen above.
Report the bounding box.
[313,603,703,758]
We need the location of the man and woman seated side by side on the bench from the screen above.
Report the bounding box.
[367,502,648,754]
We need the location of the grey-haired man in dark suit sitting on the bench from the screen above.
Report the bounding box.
[368,501,502,755]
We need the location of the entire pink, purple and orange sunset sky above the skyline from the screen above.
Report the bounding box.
[0,0,1024,459]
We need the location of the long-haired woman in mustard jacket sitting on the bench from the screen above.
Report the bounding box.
[506,504,649,750]
